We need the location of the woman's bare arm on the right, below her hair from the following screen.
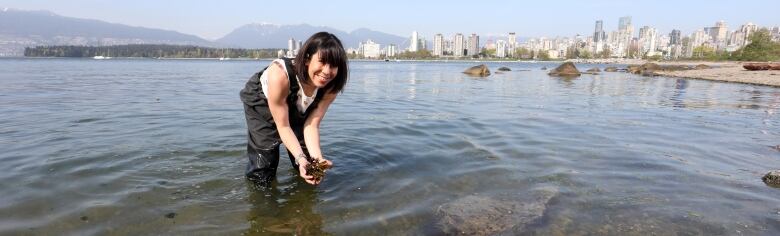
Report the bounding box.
[303,90,338,166]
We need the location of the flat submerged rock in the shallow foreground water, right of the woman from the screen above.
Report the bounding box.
[436,187,558,235]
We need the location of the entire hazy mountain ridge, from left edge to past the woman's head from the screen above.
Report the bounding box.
[0,8,408,56]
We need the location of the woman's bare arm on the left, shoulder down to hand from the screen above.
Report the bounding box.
[266,62,319,184]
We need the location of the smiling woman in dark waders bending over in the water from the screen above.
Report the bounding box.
[241,32,348,185]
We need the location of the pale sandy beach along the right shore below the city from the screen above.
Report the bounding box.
[632,62,780,87]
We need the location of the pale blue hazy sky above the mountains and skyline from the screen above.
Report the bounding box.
[0,0,780,39]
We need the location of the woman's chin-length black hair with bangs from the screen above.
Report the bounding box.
[294,32,349,93]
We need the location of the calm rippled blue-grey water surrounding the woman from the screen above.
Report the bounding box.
[0,59,780,235]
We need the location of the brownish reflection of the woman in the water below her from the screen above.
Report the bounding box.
[244,181,325,235]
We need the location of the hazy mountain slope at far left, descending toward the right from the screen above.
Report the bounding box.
[0,8,216,56]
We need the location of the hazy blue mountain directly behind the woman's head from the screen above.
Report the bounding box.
[216,23,408,48]
